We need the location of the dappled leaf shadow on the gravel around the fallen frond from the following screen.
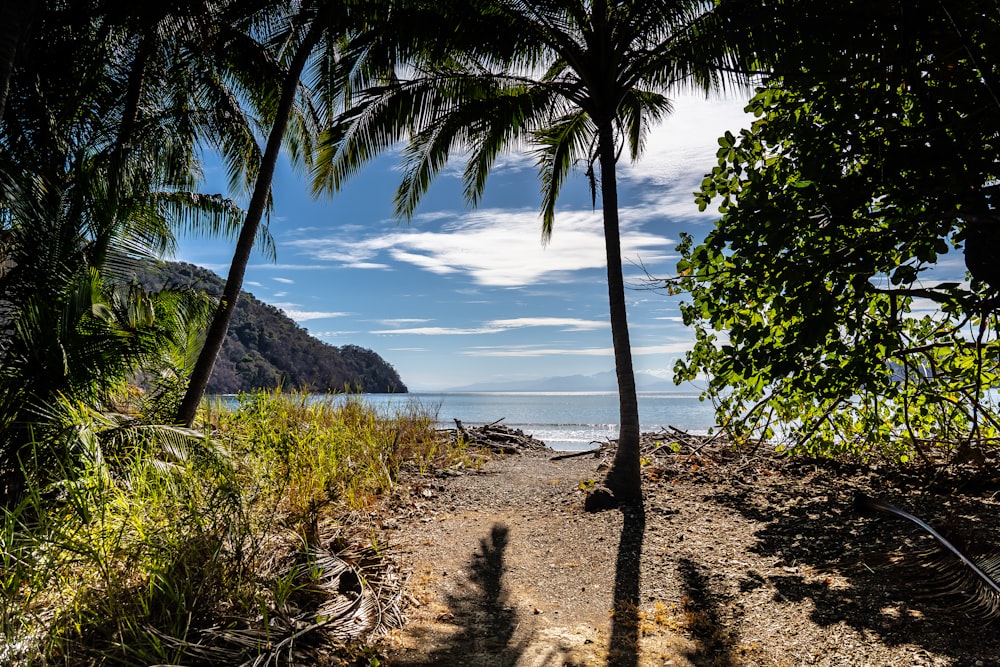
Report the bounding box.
[708,463,1000,667]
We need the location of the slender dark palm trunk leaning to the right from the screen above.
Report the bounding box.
[177,17,322,426]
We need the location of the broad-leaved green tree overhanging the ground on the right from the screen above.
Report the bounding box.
[673,0,1000,460]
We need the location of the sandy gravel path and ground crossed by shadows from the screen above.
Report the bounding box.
[376,450,1000,667]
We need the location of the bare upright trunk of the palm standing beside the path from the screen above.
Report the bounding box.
[597,122,642,503]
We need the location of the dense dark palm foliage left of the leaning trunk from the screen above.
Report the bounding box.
[0,3,255,502]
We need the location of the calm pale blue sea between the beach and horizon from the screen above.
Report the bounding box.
[316,392,715,450]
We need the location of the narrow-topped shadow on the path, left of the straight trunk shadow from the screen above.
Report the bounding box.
[395,523,530,667]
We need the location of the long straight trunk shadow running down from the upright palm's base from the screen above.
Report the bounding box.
[608,500,646,667]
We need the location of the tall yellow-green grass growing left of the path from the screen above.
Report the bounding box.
[0,393,465,665]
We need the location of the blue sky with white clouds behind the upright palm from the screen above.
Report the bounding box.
[175,91,751,391]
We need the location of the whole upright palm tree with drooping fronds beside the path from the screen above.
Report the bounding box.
[315,0,749,500]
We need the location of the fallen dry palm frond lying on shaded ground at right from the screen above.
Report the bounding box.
[855,494,1000,621]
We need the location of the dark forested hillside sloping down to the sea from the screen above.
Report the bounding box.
[137,262,406,394]
